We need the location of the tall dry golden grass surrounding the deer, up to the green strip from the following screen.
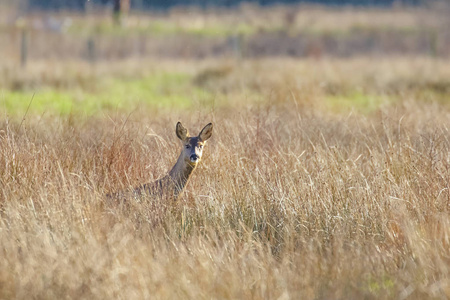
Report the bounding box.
[0,73,450,299]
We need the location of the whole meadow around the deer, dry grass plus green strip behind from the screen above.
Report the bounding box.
[0,3,450,299]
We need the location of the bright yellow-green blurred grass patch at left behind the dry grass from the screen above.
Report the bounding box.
[0,73,213,117]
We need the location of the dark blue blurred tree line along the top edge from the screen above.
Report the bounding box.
[6,0,429,12]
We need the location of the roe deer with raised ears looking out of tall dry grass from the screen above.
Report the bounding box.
[110,122,213,200]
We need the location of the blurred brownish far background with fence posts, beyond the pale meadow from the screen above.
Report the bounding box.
[0,0,450,60]
